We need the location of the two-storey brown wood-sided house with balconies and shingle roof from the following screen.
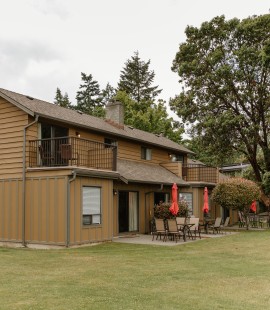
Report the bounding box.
[0,89,219,246]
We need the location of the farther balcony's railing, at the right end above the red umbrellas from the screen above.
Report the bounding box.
[182,164,218,183]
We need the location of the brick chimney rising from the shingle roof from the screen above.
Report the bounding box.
[106,101,124,129]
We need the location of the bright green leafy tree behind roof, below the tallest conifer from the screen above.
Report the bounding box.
[115,91,184,143]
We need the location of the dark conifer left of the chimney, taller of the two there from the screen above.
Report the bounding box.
[76,72,105,117]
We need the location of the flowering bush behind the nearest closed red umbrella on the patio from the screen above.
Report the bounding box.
[154,199,188,220]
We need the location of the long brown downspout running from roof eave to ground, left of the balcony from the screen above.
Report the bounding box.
[22,115,39,247]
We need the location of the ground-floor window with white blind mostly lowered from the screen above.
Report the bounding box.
[82,186,101,225]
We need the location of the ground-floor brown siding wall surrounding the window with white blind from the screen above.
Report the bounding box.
[70,177,113,245]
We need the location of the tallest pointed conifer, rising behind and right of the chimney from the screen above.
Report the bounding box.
[118,52,162,103]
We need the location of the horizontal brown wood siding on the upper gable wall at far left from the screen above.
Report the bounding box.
[0,99,28,179]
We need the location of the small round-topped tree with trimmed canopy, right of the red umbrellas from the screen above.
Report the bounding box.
[211,178,260,229]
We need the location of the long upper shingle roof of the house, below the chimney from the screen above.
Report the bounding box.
[0,88,193,153]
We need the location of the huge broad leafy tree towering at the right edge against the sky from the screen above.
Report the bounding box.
[170,14,270,193]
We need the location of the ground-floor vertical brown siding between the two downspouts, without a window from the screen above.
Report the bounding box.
[25,177,68,245]
